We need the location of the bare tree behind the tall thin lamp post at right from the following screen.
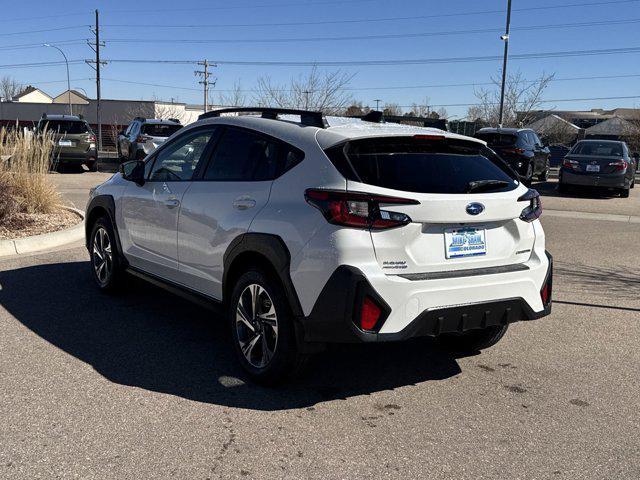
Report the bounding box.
[467,72,555,127]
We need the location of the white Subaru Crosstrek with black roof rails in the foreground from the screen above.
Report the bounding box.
[86,108,552,382]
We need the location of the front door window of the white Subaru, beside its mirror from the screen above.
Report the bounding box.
[148,128,214,182]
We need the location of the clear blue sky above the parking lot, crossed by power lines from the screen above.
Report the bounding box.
[0,0,640,116]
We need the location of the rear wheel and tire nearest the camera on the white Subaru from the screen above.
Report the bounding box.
[227,268,306,385]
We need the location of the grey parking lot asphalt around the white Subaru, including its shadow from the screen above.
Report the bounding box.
[0,173,640,479]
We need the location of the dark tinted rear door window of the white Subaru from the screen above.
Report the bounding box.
[204,128,280,181]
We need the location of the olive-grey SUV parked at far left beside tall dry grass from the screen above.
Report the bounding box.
[36,114,98,172]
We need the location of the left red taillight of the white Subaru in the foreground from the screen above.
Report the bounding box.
[304,189,420,230]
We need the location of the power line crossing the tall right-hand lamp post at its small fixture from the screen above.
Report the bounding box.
[101,18,640,44]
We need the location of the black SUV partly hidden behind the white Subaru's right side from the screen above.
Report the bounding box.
[475,128,550,184]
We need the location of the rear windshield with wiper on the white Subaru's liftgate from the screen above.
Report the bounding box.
[328,138,518,193]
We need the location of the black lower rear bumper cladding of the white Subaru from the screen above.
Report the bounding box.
[302,255,553,343]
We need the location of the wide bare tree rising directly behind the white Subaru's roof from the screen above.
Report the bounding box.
[254,67,354,115]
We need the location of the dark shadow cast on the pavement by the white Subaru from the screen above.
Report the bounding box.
[0,262,460,410]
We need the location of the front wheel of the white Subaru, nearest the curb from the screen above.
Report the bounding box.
[89,216,124,292]
